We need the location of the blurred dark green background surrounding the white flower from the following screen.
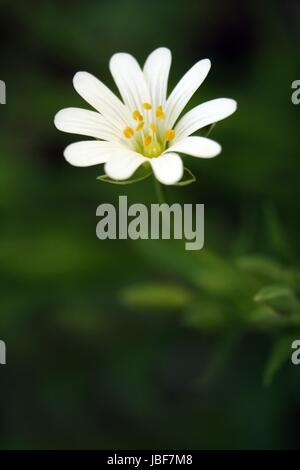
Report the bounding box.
[0,0,300,449]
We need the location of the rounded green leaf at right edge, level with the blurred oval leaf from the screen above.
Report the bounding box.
[254,285,298,312]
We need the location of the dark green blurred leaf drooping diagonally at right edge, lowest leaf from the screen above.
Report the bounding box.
[263,335,295,386]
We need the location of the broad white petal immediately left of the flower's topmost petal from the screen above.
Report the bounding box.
[109,52,150,111]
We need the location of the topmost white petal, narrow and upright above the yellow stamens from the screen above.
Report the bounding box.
[144,47,172,109]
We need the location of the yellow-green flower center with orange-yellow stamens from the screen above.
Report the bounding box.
[123,103,175,158]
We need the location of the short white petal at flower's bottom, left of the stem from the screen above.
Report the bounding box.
[104,150,148,181]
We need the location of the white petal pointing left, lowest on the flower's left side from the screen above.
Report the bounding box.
[64,140,124,167]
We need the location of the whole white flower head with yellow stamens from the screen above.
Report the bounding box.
[55,47,236,184]
